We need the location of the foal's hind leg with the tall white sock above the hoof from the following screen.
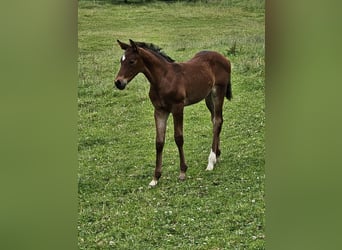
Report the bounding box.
[206,85,226,171]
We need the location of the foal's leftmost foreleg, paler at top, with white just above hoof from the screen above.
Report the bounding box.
[149,109,169,186]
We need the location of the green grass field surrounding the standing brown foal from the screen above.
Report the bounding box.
[78,0,265,249]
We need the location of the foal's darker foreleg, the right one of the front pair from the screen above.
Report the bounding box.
[172,105,188,181]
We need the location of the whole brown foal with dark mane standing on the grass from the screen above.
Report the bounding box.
[115,40,232,186]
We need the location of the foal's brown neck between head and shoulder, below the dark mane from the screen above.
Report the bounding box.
[140,49,170,86]
